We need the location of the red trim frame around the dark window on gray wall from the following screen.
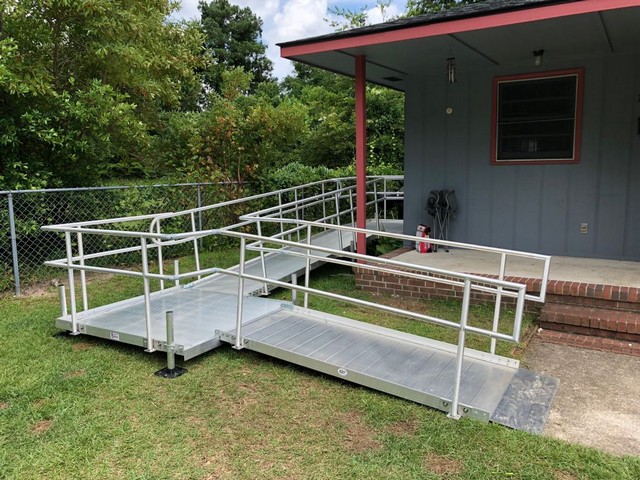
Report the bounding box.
[491,68,584,165]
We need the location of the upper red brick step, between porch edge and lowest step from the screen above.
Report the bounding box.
[540,303,640,342]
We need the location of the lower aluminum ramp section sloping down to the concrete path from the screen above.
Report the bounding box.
[221,307,550,432]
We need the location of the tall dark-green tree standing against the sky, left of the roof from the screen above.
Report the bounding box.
[198,0,273,93]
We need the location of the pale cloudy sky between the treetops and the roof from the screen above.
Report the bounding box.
[173,0,406,79]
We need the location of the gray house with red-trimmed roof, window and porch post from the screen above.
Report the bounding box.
[280,0,640,261]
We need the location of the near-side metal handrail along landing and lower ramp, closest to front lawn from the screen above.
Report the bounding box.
[45,214,526,418]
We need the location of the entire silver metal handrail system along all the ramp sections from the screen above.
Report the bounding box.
[44,177,550,418]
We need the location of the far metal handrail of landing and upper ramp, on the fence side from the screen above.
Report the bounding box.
[42,175,404,333]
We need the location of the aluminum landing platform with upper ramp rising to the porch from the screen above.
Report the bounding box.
[56,220,402,360]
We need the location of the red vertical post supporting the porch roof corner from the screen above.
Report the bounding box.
[355,55,367,255]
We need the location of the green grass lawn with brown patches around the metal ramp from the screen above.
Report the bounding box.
[0,249,640,480]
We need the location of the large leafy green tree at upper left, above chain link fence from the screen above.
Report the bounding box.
[0,0,201,188]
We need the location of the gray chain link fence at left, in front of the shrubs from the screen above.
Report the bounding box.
[0,183,241,295]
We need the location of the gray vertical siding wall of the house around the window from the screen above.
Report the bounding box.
[404,55,640,260]
